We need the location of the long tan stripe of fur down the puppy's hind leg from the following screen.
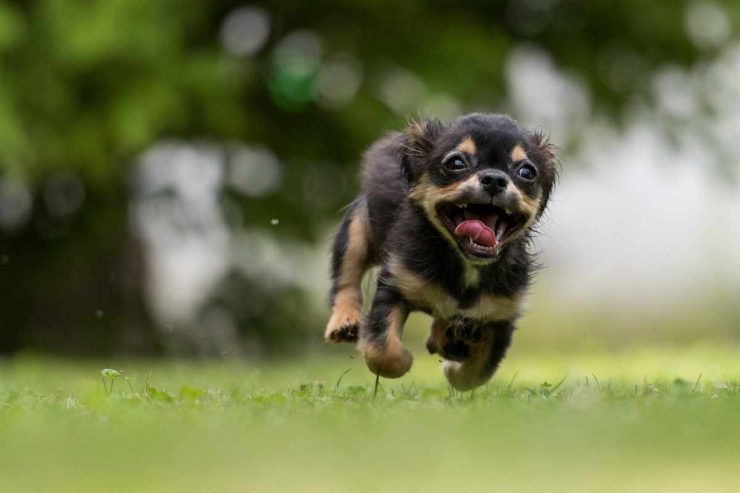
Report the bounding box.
[324,206,368,342]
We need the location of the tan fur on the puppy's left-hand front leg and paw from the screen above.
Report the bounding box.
[362,306,413,378]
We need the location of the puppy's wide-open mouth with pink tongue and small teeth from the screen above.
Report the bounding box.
[437,203,526,258]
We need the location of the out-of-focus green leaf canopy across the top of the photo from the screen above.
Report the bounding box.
[0,0,728,194]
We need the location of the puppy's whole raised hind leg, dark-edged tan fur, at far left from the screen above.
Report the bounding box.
[324,199,370,342]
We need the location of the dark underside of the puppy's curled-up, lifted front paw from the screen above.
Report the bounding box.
[427,319,487,361]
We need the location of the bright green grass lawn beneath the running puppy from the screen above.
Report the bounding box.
[0,345,740,492]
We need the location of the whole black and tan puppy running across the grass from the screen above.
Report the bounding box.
[325,114,556,390]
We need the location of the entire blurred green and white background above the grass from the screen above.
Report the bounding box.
[0,0,740,358]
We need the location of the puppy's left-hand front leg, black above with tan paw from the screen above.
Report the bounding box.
[360,273,413,378]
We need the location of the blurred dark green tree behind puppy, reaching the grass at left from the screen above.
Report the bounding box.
[0,0,740,352]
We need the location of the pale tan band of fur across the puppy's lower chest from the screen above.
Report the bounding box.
[391,265,522,321]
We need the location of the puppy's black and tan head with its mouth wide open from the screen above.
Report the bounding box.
[402,114,556,264]
